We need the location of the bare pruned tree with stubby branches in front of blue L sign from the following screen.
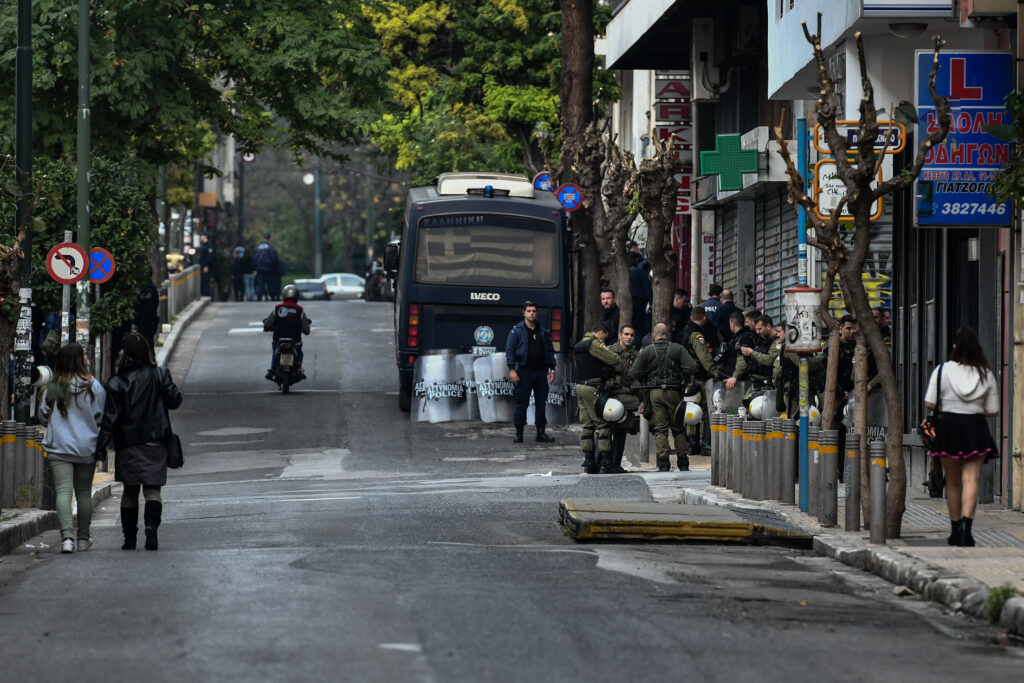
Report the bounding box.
[776,14,949,538]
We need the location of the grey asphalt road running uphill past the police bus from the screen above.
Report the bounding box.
[0,302,1024,683]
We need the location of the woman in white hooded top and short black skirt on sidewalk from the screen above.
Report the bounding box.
[925,328,999,546]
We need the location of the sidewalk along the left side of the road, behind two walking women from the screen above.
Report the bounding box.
[0,298,209,556]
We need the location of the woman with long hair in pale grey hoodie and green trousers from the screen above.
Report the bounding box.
[39,344,105,553]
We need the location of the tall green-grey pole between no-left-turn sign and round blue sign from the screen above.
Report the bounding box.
[75,0,96,368]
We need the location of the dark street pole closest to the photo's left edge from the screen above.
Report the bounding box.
[12,0,32,423]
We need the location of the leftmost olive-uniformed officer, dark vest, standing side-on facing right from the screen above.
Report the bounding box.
[572,321,622,474]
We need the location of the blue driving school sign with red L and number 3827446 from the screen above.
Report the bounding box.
[914,50,1014,226]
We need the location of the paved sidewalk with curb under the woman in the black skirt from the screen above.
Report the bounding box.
[662,475,1024,636]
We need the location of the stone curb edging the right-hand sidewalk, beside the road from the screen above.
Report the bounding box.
[679,488,1024,636]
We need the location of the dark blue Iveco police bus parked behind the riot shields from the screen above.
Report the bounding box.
[384,173,572,411]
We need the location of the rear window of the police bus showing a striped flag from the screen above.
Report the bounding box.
[416,218,559,287]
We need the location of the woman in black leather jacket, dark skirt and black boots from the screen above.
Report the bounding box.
[98,332,181,550]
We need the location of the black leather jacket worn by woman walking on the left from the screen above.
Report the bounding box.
[96,358,181,451]
